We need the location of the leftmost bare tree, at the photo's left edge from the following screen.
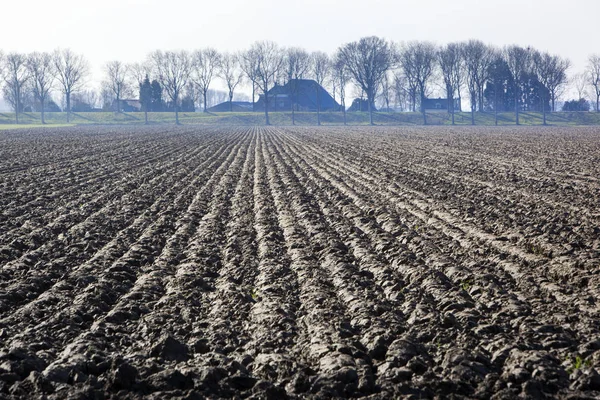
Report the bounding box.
[3,53,31,124]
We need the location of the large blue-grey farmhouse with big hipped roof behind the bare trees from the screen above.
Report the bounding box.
[254,79,340,111]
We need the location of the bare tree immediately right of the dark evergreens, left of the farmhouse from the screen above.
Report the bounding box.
[150,50,191,125]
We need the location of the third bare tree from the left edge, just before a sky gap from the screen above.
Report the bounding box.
[53,49,89,122]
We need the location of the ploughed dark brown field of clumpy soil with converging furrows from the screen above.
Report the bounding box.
[0,127,600,399]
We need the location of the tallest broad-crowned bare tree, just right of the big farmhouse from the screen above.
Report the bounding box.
[338,36,395,125]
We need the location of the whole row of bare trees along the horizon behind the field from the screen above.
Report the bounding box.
[0,36,600,124]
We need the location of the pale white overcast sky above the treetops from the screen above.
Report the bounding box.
[0,0,600,93]
